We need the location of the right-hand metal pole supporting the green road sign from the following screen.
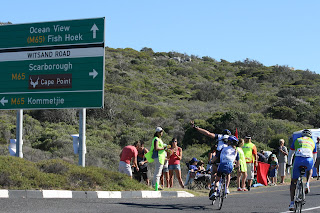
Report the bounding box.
[79,108,86,167]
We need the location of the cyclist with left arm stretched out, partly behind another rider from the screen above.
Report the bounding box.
[190,121,231,186]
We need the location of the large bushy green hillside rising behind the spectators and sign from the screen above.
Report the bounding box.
[0,47,320,188]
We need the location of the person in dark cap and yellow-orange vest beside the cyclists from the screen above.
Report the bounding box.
[242,135,258,191]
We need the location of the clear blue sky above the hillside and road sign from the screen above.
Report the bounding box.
[0,0,320,74]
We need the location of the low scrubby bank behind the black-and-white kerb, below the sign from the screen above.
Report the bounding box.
[0,156,148,191]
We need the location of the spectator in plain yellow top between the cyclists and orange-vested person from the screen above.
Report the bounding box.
[237,139,248,191]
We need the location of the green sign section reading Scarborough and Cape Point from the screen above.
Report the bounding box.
[0,56,103,94]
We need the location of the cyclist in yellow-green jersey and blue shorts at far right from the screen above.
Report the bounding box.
[288,129,317,211]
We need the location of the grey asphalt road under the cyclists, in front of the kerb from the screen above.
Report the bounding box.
[0,181,320,213]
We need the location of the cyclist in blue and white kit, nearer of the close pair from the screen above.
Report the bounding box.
[209,135,239,200]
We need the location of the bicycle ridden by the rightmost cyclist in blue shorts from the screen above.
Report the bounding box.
[294,166,307,213]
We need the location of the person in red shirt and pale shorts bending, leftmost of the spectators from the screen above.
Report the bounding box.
[119,141,140,178]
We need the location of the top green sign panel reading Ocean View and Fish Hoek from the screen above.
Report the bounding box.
[0,18,104,49]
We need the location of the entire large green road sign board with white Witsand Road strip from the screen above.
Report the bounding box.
[0,18,104,109]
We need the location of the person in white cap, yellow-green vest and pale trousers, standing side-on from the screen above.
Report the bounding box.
[145,127,167,191]
